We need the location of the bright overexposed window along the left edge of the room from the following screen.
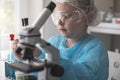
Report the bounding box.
[0,0,16,59]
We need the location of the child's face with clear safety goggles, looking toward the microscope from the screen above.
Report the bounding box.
[53,3,87,38]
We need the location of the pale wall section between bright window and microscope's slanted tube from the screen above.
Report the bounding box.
[16,0,44,33]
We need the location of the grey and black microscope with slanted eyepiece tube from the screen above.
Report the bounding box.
[9,2,64,80]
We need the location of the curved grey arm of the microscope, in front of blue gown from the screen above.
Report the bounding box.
[38,39,60,64]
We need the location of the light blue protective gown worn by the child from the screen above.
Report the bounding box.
[39,34,109,80]
